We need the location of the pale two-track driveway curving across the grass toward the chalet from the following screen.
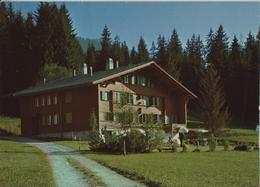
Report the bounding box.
[1,137,145,187]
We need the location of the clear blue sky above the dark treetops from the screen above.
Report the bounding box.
[13,2,260,48]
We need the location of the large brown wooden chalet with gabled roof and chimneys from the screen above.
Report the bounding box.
[14,59,196,138]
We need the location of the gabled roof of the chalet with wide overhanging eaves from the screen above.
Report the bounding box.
[13,61,197,98]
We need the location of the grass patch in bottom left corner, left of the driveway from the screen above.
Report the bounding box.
[0,140,55,187]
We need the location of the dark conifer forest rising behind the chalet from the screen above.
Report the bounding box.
[0,2,260,128]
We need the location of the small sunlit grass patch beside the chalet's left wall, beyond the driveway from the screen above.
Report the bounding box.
[0,116,21,135]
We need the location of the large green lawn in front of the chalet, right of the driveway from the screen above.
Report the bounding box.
[85,151,259,187]
